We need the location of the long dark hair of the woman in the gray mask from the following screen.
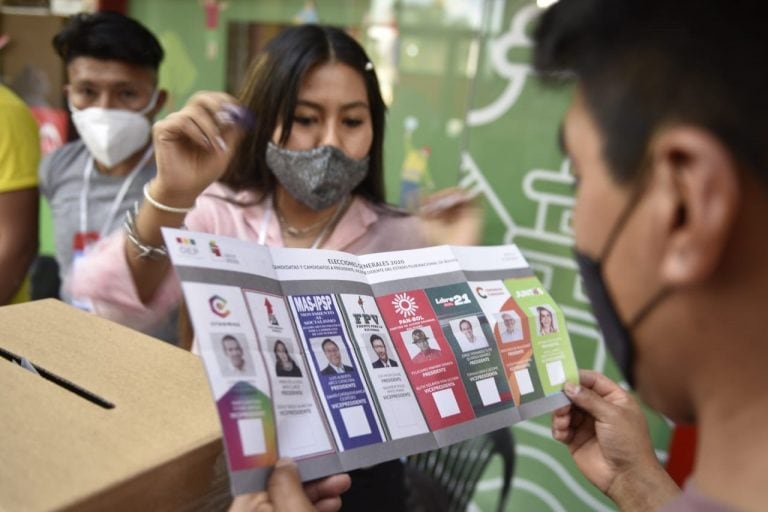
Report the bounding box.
[220,25,386,204]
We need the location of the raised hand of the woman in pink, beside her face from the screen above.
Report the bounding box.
[151,92,242,207]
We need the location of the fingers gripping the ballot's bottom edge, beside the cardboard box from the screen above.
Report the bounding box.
[229,459,351,512]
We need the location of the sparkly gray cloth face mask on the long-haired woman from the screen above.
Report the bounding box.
[267,142,370,210]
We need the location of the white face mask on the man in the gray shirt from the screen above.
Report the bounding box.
[69,89,158,167]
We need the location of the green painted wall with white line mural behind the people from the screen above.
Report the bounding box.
[126,0,669,511]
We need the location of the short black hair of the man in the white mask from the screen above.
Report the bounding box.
[53,11,164,71]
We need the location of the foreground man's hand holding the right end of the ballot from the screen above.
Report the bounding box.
[552,370,680,510]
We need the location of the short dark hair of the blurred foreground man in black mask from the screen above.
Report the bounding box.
[534,0,768,188]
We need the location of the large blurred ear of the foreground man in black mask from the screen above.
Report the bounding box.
[650,125,741,285]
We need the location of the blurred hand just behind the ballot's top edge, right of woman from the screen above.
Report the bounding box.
[418,187,483,245]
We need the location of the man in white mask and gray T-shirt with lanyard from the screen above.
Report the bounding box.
[38,12,167,337]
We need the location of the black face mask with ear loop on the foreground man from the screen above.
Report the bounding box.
[573,189,667,387]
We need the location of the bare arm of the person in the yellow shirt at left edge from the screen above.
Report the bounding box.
[0,187,38,305]
